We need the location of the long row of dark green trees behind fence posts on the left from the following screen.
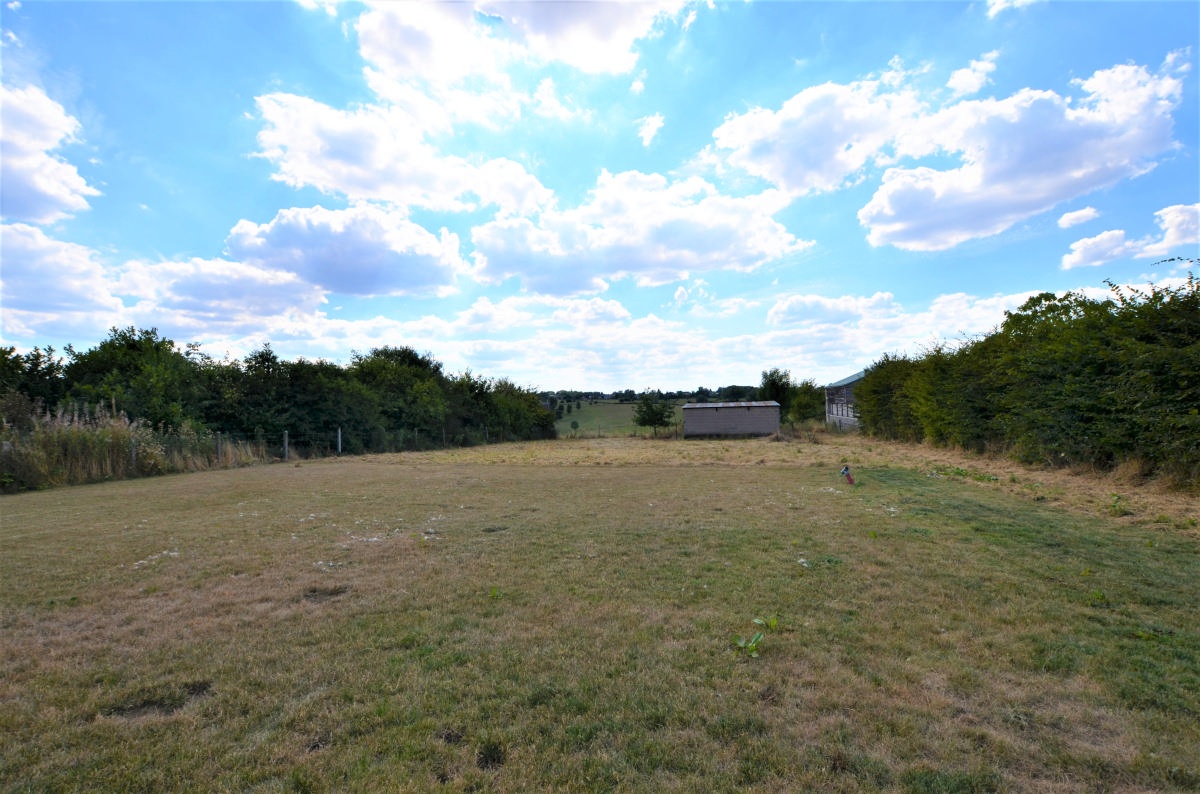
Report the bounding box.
[0,327,554,489]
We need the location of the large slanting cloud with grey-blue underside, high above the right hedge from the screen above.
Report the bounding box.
[858,57,1182,251]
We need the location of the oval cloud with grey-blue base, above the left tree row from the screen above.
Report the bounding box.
[226,205,467,295]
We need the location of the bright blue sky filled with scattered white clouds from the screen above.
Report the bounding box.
[0,0,1200,391]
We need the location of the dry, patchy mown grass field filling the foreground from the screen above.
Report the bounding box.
[0,437,1200,792]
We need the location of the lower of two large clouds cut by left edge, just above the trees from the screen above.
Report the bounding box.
[0,223,122,338]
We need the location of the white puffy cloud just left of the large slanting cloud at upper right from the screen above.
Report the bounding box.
[713,80,919,196]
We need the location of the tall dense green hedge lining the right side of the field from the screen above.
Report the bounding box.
[854,276,1200,487]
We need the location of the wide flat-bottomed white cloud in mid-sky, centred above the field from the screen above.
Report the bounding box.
[472,172,811,294]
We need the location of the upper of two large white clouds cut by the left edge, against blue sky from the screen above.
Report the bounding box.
[0,85,100,224]
